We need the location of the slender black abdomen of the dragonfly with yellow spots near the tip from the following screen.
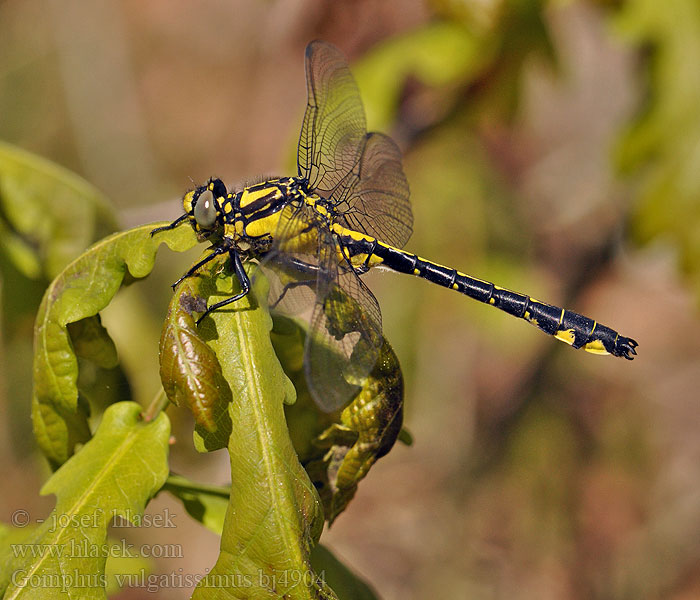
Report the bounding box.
[372,242,637,360]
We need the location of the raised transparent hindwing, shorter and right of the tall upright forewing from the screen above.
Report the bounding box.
[330,133,413,248]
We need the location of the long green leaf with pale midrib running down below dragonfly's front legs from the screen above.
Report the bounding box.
[176,257,335,599]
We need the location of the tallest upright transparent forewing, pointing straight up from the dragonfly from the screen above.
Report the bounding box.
[297,41,367,198]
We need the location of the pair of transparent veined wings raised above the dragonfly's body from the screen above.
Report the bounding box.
[297,41,413,248]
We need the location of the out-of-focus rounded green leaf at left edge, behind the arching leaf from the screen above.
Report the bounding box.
[0,143,116,279]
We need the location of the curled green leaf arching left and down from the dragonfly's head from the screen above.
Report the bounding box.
[32,225,197,466]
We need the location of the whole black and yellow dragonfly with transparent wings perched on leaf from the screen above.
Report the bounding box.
[151,41,637,412]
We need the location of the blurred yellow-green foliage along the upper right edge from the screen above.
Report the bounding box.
[614,0,700,300]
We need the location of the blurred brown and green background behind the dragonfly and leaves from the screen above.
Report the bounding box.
[0,0,700,600]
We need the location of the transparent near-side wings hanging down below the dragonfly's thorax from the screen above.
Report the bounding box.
[261,205,382,412]
